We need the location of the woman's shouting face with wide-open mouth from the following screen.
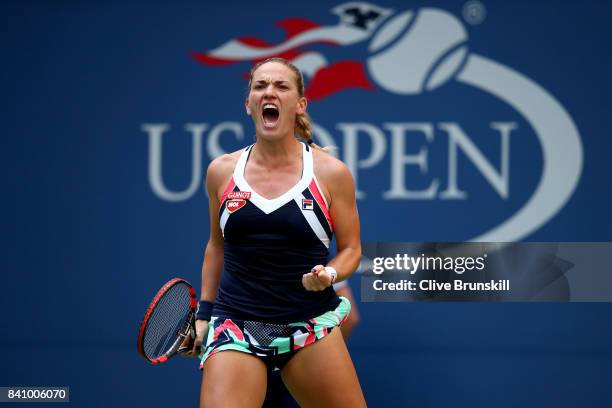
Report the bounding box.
[246,62,306,140]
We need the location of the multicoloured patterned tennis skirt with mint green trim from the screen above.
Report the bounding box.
[200,297,351,369]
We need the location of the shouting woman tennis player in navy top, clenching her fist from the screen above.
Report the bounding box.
[180,58,365,407]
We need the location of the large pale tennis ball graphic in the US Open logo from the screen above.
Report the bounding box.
[367,8,468,95]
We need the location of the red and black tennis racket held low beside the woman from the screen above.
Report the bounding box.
[137,278,197,364]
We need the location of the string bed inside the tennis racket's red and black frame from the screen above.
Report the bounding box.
[143,283,190,359]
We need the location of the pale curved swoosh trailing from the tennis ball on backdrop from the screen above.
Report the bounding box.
[456,54,583,242]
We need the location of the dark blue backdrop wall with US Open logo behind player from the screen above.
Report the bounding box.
[0,0,612,407]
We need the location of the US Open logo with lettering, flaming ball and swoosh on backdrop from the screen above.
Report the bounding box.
[143,2,583,241]
